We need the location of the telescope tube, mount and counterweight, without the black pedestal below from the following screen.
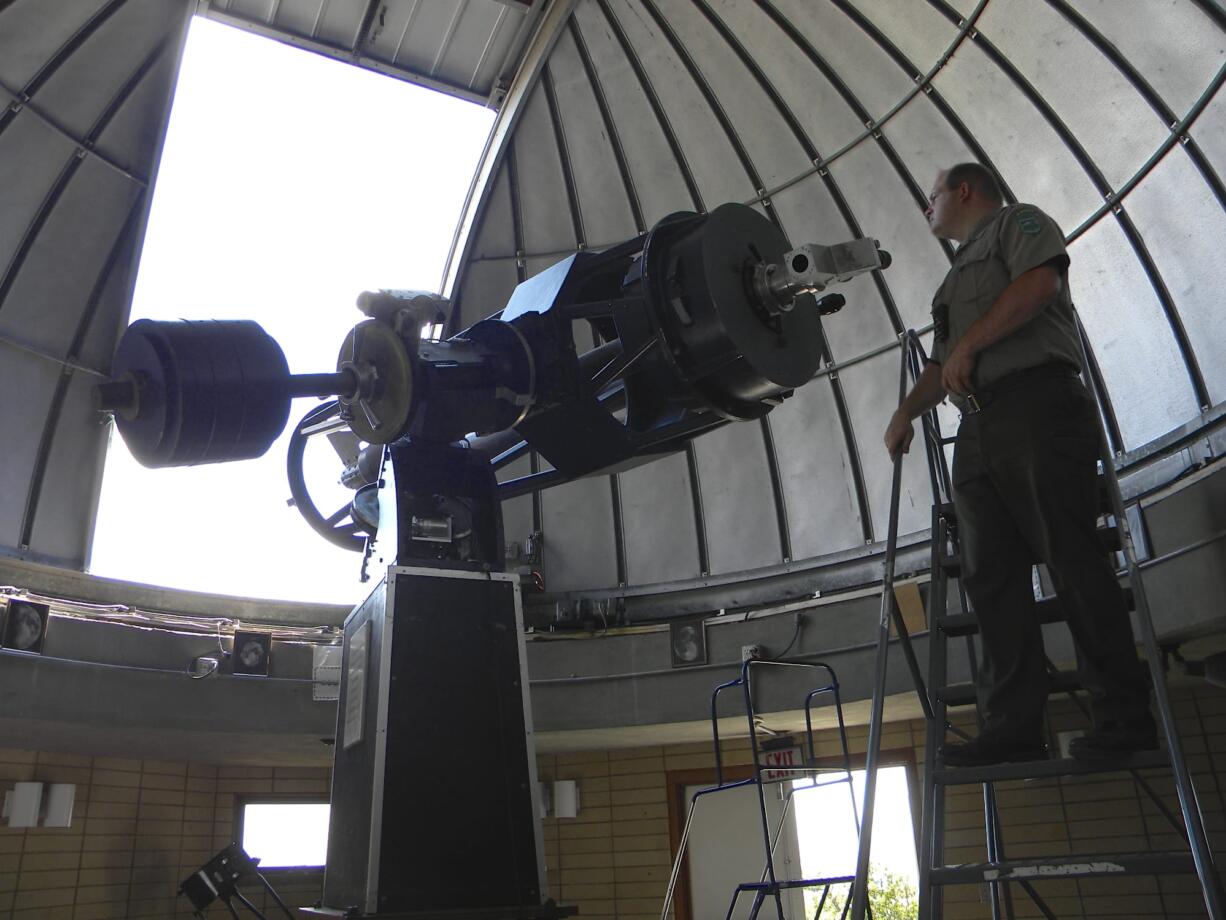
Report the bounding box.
[94,204,890,572]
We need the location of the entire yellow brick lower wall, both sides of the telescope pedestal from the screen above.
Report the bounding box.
[0,684,1226,920]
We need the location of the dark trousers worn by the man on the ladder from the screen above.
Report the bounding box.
[954,377,1149,738]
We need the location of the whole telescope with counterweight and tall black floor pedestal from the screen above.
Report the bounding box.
[96,204,890,920]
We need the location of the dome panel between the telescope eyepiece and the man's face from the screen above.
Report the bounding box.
[829,144,949,338]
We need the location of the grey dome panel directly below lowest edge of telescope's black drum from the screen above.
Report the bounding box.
[694,422,782,574]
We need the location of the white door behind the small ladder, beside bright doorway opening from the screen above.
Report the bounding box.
[685,784,804,920]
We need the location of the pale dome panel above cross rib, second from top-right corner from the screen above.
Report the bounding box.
[978,0,1167,188]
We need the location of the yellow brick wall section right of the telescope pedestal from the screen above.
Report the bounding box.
[539,684,1226,920]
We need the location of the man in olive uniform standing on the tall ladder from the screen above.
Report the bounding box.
[885,163,1157,765]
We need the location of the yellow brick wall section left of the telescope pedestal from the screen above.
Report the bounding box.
[0,748,329,920]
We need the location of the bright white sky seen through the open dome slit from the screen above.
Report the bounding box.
[89,17,501,604]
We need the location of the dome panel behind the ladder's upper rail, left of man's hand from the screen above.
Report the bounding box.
[839,348,926,540]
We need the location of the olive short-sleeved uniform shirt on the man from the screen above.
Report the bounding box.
[932,204,1081,410]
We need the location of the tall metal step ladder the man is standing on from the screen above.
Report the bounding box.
[882,331,1226,920]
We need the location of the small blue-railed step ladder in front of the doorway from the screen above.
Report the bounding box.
[660,659,862,920]
